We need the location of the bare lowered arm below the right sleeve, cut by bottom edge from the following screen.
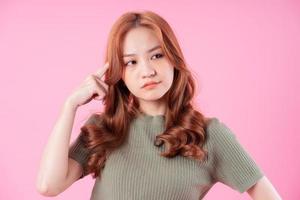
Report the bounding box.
[247,176,281,200]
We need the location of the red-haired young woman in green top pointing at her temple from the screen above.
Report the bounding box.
[37,11,280,200]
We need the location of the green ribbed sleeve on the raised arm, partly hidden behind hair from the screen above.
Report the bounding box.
[69,114,95,179]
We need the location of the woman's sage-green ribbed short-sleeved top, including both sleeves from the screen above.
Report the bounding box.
[69,114,263,200]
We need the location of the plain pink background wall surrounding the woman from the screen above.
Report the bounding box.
[0,0,300,200]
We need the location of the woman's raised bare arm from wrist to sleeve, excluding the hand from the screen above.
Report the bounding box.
[36,100,82,196]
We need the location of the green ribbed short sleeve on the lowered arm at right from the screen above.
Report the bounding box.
[208,118,264,193]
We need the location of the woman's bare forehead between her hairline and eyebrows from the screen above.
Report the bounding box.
[123,27,160,54]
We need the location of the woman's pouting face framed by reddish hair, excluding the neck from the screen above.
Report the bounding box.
[122,27,174,101]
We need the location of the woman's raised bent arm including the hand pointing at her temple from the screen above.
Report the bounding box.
[36,63,108,196]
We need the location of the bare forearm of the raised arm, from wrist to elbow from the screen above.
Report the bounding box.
[36,100,77,193]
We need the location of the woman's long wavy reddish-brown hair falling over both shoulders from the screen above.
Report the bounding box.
[81,11,207,178]
